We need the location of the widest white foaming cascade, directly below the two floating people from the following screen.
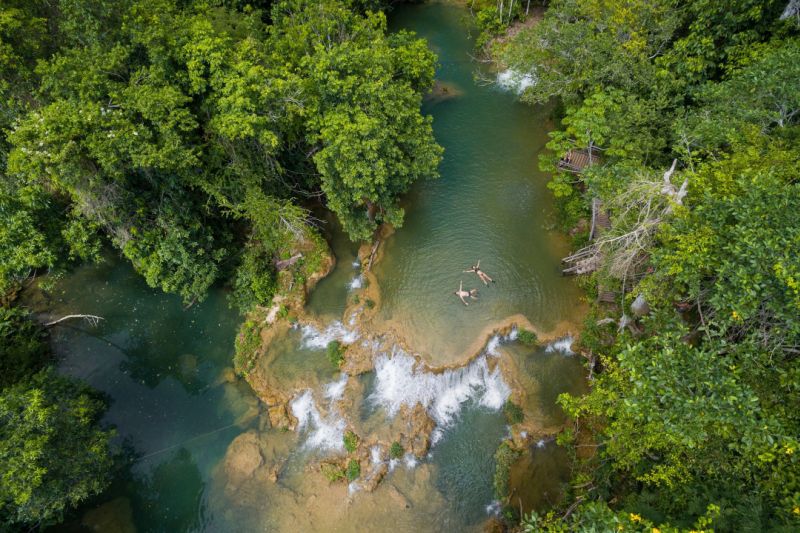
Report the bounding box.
[370,347,511,427]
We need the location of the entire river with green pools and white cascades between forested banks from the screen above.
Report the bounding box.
[48,3,584,532]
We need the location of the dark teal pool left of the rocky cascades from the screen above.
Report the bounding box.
[31,256,253,531]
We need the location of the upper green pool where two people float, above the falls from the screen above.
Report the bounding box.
[375,4,577,365]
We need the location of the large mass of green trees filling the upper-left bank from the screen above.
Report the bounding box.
[0,0,441,309]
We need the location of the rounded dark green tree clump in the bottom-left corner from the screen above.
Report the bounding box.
[0,370,112,527]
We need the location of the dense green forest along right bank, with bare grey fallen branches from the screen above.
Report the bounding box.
[503,0,800,531]
